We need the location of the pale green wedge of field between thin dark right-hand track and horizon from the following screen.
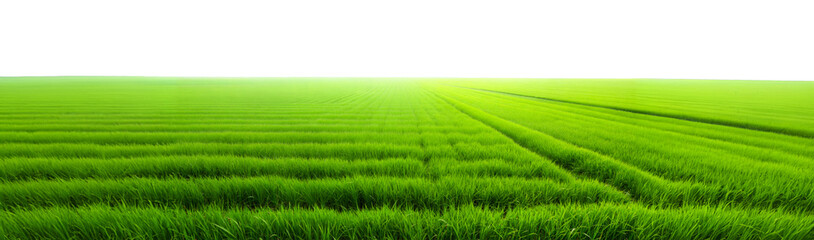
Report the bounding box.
[440,79,814,138]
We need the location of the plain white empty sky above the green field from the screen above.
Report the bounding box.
[0,0,814,80]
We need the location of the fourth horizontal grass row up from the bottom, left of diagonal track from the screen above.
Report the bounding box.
[0,143,580,163]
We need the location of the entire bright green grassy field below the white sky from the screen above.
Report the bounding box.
[0,77,814,239]
